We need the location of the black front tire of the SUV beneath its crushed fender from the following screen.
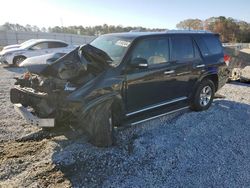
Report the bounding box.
[78,102,114,147]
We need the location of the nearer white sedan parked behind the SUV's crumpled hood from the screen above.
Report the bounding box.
[0,39,75,66]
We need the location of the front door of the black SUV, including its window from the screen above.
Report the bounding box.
[126,37,184,114]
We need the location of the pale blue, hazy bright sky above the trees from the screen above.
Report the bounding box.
[0,0,250,29]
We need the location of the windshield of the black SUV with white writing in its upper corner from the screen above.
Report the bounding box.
[90,35,132,66]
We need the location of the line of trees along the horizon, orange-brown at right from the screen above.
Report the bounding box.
[0,16,250,43]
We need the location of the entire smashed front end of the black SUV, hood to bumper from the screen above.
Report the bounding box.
[10,44,112,127]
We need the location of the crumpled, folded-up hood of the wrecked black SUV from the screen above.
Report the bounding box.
[20,44,112,80]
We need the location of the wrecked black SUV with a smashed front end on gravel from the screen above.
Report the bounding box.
[10,31,229,146]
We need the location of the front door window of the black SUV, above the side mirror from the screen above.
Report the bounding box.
[132,38,169,65]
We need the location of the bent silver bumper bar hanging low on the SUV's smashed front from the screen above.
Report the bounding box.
[14,104,55,127]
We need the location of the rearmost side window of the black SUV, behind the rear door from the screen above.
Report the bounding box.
[196,36,222,56]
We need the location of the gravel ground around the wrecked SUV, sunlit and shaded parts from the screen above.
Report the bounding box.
[0,67,250,187]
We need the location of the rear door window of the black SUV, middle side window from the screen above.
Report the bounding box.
[171,36,194,60]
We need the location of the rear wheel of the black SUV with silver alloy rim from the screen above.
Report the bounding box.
[191,79,215,111]
